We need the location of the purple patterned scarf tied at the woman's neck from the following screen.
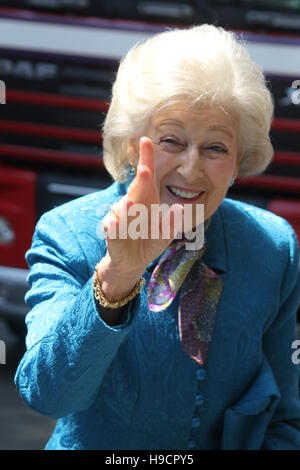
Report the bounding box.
[148,219,223,366]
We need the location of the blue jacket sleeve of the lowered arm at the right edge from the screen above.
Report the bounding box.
[262,221,300,450]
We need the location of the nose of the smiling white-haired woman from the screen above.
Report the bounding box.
[178,145,205,183]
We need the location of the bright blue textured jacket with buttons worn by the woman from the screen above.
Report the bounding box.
[15,178,300,450]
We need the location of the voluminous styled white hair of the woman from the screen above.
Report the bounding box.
[102,24,274,183]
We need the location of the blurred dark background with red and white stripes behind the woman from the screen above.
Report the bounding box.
[0,0,300,449]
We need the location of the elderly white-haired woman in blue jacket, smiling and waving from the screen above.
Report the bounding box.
[15,25,300,450]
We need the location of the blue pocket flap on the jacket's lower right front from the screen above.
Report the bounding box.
[221,356,280,450]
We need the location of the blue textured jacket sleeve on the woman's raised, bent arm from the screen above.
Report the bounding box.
[15,211,140,418]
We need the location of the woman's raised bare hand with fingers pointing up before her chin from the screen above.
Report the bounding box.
[98,137,183,298]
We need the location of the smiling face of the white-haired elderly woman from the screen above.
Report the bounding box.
[128,104,238,227]
